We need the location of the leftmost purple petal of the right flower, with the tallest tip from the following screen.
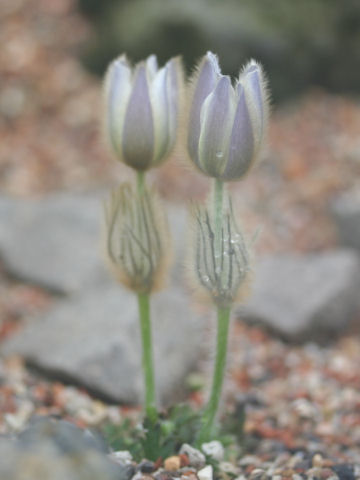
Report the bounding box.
[188,52,221,163]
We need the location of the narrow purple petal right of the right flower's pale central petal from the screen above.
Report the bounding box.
[221,85,254,181]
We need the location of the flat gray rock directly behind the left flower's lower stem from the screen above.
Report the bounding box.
[2,284,204,403]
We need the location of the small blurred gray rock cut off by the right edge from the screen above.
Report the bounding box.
[331,189,360,252]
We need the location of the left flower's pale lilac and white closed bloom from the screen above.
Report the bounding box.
[105,55,182,171]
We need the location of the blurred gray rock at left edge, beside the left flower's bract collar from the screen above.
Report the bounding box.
[0,193,109,293]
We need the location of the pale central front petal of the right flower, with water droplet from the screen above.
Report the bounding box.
[199,76,235,177]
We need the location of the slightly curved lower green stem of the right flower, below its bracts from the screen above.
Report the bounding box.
[197,307,230,446]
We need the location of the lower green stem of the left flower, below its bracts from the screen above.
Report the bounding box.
[138,293,157,423]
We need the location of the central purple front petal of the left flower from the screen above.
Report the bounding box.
[122,64,154,170]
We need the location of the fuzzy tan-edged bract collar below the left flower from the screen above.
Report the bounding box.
[105,184,171,293]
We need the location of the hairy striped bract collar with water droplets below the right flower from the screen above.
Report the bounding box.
[190,198,250,307]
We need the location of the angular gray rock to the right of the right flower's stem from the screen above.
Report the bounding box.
[238,250,360,341]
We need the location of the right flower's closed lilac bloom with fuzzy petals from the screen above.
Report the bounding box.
[188,52,268,181]
